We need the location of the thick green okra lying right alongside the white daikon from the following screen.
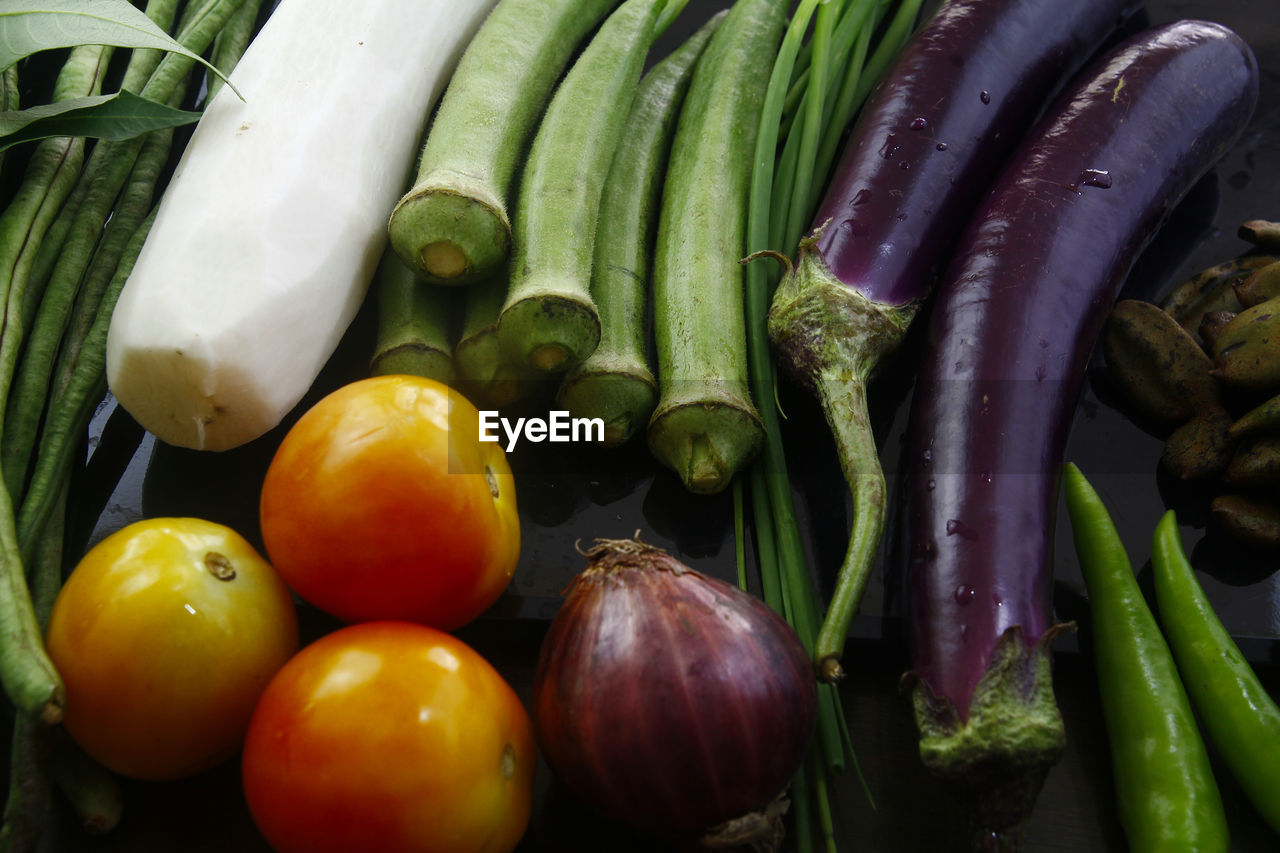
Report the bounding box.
[388,0,627,284]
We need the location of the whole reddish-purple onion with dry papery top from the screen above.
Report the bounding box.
[531,542,817,840]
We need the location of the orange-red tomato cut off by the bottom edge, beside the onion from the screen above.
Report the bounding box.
[242,621,536,853]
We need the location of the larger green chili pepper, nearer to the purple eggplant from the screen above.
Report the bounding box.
[1065,465,1229,853]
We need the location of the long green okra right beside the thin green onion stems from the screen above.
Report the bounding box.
[648,0,788,493]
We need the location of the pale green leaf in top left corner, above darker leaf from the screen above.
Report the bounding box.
[0,0,235,92]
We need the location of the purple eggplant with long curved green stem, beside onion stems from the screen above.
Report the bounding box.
[769,0,1134,680]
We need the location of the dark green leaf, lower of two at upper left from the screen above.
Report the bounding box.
[0,91,200,151]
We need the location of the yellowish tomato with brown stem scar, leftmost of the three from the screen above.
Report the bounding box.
[45,519,298,780]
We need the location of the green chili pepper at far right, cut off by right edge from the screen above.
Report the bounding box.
[1151,510,1280,833]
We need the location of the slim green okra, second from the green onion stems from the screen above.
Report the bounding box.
[557,13,724,446]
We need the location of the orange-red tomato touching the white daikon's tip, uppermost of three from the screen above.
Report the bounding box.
[260,375,520,630]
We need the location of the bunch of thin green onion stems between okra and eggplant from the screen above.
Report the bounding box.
[745,0,920,835]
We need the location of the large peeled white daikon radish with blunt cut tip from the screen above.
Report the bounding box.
[106,0,494,450]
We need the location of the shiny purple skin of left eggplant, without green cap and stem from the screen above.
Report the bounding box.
[814,0,1135,305]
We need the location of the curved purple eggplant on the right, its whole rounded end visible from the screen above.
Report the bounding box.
[905,20,1258,841]
